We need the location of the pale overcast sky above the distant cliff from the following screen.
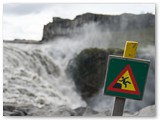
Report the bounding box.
[3,3,155,40]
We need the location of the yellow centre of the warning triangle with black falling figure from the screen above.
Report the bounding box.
[117,70,136,91]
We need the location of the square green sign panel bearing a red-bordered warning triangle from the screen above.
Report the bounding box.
[104,55,150,100]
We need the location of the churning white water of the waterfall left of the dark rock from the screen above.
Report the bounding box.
[3,43,86,108]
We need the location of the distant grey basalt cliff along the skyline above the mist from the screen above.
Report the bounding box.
[42,13,155,42]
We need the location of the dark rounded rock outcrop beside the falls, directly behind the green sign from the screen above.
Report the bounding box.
[66,48,123,100]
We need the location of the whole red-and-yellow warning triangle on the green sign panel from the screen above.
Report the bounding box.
[107,65,140,95]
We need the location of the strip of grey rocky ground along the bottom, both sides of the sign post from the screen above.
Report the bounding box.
[3,104,156,117]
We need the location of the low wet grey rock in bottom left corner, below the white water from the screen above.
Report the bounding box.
[3,104,77,117]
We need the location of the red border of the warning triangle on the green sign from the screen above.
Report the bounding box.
[107,64,140,95]
